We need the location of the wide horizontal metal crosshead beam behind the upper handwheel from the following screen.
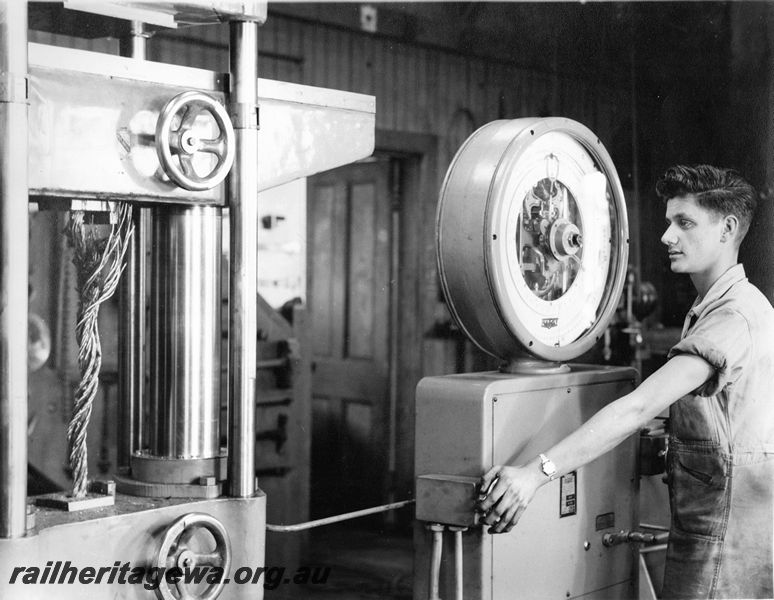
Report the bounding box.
[29,42,375,206]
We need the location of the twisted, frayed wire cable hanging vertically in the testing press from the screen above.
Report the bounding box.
[65,203,133,498]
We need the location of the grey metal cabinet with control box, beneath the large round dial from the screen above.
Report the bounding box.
[414,365,637,600]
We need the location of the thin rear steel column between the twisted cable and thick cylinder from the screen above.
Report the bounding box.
[117,21,148,467]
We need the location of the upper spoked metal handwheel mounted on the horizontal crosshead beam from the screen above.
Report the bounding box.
[156,91,235,192]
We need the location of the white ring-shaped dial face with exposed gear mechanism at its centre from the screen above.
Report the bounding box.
[492,132,620,347]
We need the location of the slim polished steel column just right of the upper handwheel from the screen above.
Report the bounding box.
[228,21,258,498]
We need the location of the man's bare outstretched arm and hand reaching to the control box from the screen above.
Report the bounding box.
[476,354,714,533]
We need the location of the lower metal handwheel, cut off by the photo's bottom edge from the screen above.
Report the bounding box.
[155,513,231,600]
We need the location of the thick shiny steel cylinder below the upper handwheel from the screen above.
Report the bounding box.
[147,205,223,459]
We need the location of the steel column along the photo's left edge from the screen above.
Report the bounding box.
[0,0,29,538]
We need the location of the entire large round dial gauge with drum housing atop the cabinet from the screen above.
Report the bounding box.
[437,118,629,362]
